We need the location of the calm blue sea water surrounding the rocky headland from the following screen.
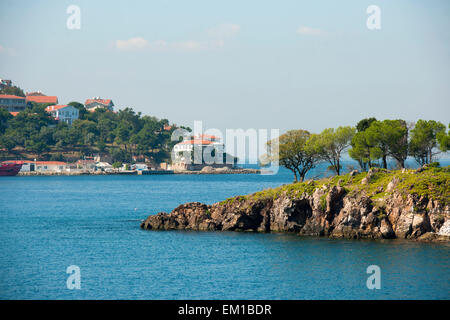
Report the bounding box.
[0,165,450,299]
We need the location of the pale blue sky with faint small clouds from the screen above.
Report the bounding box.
[0,0,450,136]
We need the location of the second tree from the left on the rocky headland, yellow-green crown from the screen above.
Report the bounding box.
[308,126,355,175]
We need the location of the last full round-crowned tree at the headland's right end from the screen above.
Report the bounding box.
[409,120,445,165]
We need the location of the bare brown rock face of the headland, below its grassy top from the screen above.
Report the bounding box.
[141,169,450,241]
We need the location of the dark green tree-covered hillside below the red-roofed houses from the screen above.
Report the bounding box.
[0,102,186,163]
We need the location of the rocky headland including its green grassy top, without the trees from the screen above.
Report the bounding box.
[141,167,450,242]
